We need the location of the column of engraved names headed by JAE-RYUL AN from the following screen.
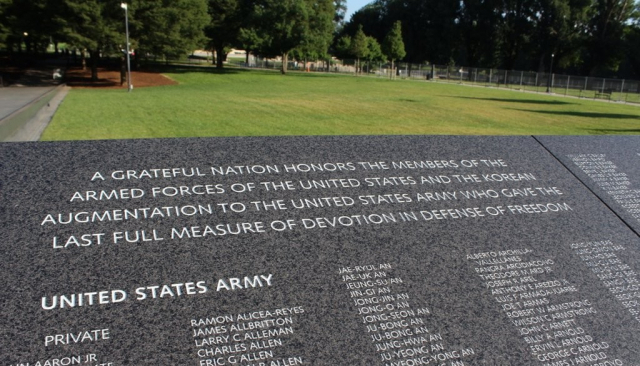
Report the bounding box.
[338,263,475,366]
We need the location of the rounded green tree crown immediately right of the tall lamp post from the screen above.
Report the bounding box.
[131,0,210,63]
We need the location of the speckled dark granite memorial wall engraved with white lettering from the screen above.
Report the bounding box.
[0,136,640,366]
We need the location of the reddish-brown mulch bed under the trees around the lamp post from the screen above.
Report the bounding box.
[64,68,178,89]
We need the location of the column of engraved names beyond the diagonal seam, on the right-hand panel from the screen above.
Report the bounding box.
[569,154,640,220]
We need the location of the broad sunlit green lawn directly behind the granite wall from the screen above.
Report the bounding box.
[42,68,640,140]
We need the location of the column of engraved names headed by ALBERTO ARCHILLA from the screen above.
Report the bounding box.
[467,248,623,366]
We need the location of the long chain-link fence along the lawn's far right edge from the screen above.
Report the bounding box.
[235,56,640,104]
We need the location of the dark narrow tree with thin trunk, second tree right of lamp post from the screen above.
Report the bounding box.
[205,0,242,69]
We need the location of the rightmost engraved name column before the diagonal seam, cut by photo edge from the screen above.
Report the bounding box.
[571,240,640,321]
